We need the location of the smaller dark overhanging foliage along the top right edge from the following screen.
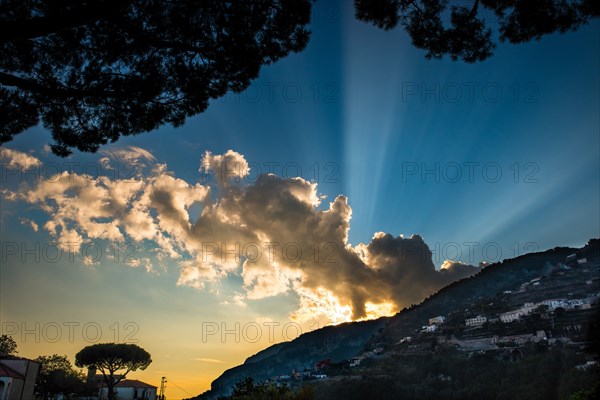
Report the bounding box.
[354,0,600,62]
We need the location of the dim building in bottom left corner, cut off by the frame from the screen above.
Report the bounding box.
[0,357,40,400]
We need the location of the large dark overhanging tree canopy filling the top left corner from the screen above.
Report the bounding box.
[0,0,310,156]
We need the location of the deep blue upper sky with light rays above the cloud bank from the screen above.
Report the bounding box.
[9,3,599,256]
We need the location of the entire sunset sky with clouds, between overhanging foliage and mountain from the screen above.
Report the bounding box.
[0,1,600,399]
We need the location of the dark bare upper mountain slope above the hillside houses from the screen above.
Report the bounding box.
[197,239,600,399]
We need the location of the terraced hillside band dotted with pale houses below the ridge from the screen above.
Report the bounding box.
[220,250,600,394]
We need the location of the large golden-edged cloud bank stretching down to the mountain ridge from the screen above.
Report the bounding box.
[5,148,478,323]
